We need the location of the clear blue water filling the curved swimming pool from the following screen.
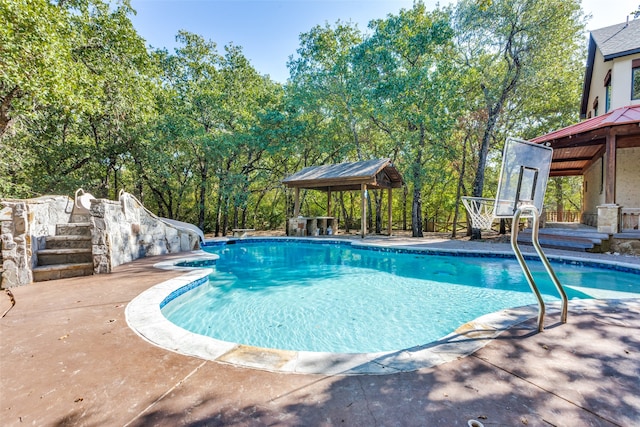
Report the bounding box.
[162,240,640,353]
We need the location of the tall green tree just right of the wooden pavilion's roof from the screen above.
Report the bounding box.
[357,2,460,237]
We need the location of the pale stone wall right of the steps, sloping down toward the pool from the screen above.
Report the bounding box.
[91,193,199,274]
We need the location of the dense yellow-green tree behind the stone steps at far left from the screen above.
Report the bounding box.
[0,0,152,197]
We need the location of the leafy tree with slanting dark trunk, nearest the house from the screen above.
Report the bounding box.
[455,0,584,238]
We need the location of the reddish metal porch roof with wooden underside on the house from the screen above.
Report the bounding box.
[531,105,640,176]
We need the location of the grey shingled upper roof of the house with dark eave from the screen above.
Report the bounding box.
[580,19,640,119]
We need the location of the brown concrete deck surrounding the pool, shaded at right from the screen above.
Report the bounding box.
[0,238,640,426]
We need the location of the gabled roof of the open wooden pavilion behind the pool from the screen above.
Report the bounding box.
[282,159,403,191]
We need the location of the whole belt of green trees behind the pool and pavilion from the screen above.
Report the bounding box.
[0,0,584,236]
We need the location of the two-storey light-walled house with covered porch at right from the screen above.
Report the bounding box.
[532,19,640,234]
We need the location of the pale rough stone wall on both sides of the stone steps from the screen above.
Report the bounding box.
[0,193,199,288]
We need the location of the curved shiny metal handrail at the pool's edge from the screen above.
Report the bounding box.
[511,205,569,332]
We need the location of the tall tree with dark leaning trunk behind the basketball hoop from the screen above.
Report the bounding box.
[456,0,583,239]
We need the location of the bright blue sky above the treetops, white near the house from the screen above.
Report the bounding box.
[131,0,640,83]
